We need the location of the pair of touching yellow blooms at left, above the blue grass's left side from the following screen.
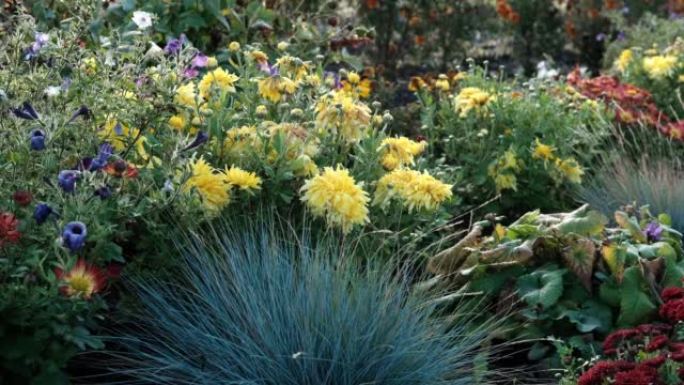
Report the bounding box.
[183,158,261,214]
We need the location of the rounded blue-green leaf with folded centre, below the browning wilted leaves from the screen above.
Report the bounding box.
[518,265,565,308]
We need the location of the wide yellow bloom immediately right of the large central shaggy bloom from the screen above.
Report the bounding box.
[373,169,452,212]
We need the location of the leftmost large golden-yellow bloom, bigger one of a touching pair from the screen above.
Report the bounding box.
[183,158,230,214]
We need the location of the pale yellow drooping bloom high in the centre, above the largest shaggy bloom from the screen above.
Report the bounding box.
[316,91,371,143]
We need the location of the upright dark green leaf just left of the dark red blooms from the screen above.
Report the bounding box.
[617,266,656,327]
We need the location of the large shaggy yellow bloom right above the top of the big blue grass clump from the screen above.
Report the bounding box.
[301,166,369,233]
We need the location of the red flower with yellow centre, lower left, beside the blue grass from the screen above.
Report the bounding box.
[55,259,107,299]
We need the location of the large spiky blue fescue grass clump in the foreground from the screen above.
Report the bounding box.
[109,222,500,385]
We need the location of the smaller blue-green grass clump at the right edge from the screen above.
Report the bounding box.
[580,157,684,231]
